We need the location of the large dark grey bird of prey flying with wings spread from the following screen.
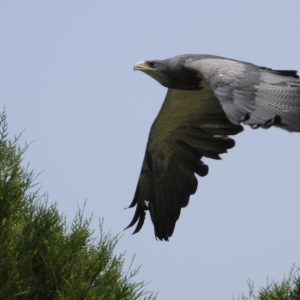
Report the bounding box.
[126,54,300,241]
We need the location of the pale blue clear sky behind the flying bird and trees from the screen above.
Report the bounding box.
[0,0,300,300]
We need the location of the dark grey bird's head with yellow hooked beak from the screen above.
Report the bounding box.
[134,56,200,90]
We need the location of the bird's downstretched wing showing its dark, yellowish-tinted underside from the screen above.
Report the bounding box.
[128,89,242,240]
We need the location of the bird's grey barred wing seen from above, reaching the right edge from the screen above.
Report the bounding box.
[186,57,300,131]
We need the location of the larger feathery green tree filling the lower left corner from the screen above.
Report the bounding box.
[0,112,155,300]
